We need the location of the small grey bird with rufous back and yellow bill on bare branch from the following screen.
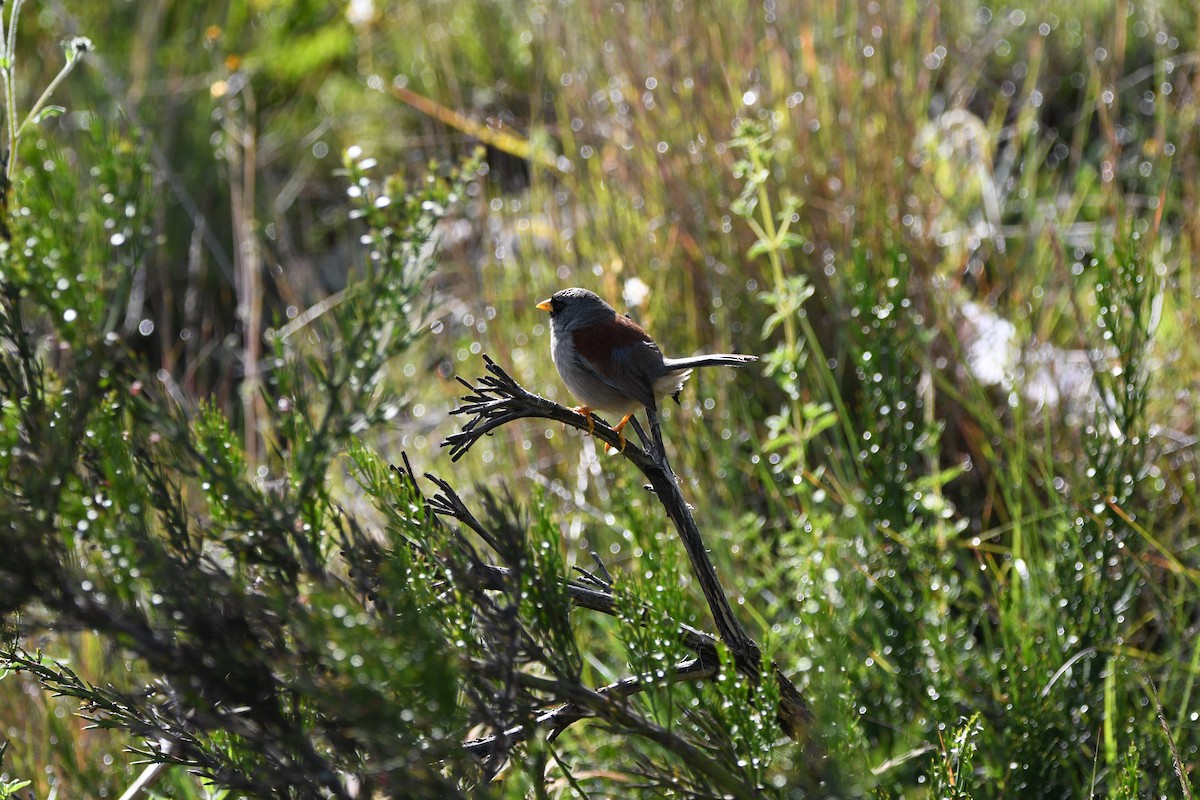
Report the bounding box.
[538,289,758,457]
